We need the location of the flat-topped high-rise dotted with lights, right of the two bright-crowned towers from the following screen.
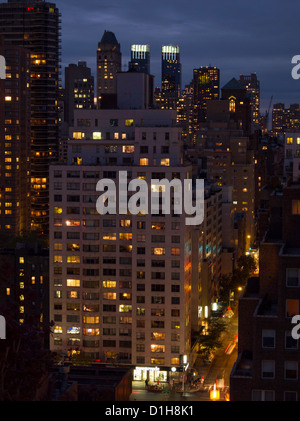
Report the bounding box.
[192,67,220,131]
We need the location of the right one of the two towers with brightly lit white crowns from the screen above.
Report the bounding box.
[161,45,181,109]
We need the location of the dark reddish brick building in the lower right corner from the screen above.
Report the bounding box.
[230,182,300,401]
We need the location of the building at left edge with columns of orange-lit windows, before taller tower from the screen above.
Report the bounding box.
[0,41,31,236]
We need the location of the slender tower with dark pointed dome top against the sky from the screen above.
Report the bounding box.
[97,31,122,109]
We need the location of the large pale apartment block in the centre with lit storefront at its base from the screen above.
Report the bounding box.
[50,105,205,379]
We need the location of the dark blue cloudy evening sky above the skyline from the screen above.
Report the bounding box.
[56,0,300,109]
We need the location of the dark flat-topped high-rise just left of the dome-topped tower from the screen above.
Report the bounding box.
[64,61,94,126]
